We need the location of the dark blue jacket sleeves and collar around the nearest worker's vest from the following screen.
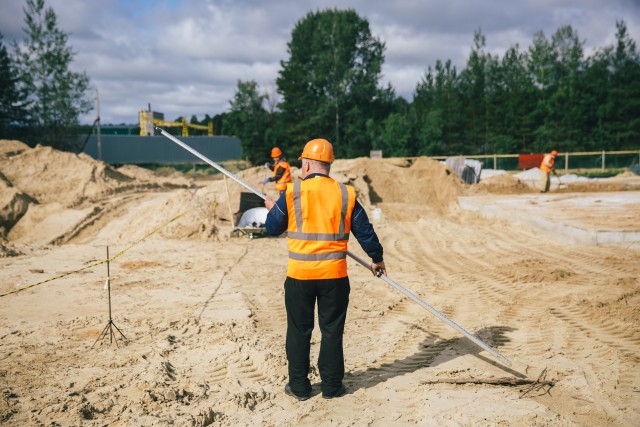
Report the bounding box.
[265,173,383,263]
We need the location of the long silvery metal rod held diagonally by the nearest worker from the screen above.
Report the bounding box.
[156,127,511,366]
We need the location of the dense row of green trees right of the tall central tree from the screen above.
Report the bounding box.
[404,22,640,154]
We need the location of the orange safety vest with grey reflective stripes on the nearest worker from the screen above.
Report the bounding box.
[286,176,356,280]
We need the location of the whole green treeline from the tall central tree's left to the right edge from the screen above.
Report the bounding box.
[214,10,640,162]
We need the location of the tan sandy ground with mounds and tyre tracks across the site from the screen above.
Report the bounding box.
[0,141,640,426]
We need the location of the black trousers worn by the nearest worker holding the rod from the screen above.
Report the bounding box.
[284,277,351,396]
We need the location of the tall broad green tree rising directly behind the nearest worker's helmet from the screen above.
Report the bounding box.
[276,9,389,157]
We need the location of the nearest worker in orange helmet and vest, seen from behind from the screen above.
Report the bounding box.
[265,139,386,400]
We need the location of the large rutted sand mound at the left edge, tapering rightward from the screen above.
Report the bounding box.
[0,140,191,246]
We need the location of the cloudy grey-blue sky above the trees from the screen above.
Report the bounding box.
[0,0,640,124]
